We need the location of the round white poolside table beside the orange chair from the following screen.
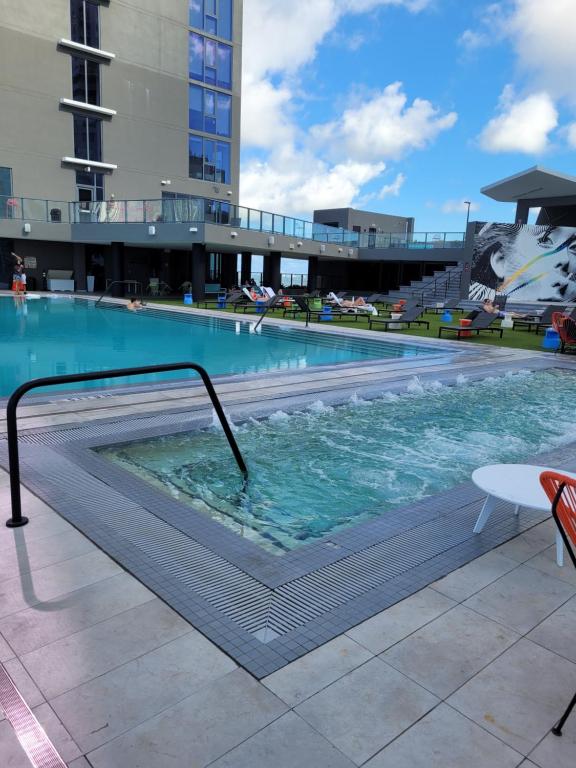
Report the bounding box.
[472,464,576,566]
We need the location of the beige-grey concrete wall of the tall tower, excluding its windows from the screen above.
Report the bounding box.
[0,0,242,202]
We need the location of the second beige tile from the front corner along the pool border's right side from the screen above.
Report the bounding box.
[346,588,455,653]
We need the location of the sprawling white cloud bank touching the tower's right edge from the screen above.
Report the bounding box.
[241,0,440,215]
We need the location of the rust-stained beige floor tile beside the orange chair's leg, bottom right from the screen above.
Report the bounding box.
[448,639,576,755]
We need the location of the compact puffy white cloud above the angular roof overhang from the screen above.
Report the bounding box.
[480,85,558,154]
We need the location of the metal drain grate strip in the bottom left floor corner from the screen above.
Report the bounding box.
[0,664,66,768]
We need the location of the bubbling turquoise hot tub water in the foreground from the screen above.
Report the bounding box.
[99,370,576,554]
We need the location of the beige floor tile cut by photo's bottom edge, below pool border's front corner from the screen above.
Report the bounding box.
[87,669,286,768]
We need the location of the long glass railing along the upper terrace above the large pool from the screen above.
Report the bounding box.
[0,196,465,249]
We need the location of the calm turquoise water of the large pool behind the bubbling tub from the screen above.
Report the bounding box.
[0,297,438,397]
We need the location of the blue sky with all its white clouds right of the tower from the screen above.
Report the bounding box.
[241,0,576,232]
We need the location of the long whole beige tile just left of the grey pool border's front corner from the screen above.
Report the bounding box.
[50,631,236,752]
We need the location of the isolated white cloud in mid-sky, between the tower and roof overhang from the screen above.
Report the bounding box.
[310,83,457,161]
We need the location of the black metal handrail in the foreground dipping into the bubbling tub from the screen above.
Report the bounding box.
[6,363,248,528]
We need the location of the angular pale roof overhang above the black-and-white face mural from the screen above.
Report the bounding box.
[480,165,576,203]
